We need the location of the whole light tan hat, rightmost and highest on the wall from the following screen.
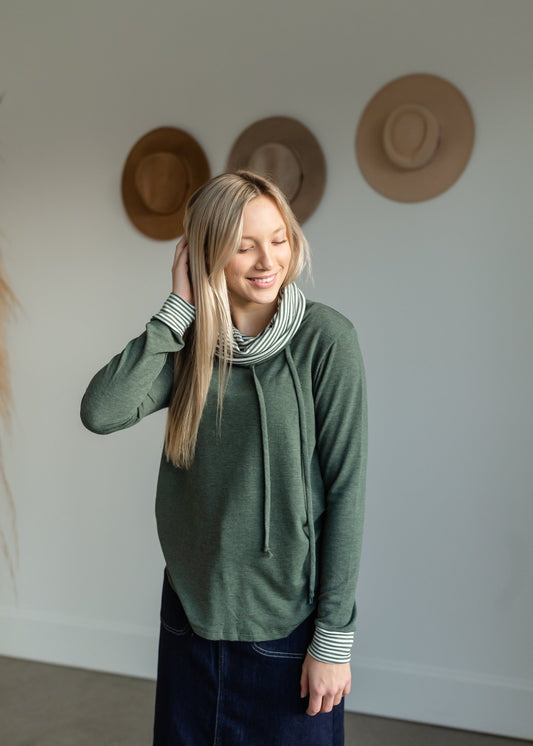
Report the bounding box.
[355,74,474,202]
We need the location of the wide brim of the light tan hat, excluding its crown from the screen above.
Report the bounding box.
[355,73,475,202]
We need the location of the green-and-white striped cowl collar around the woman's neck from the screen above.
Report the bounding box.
[221,283,305,365]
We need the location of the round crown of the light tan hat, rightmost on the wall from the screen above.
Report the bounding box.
[383,104,440,169]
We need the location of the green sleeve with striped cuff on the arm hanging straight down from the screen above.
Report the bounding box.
[310,329,367,644]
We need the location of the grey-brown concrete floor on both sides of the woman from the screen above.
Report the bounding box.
[0,657,531,746]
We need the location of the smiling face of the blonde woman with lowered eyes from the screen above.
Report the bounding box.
[224,196,291,313]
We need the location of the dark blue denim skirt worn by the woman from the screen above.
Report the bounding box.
[154,573,344,746]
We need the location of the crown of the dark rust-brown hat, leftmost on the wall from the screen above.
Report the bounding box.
[135,151,189,215]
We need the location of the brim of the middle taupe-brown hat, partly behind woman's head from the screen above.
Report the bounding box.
[227,116,326,223]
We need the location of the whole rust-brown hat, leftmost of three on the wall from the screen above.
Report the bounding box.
[122,127,210,241]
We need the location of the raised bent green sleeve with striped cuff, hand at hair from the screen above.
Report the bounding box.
[80,296,194,434]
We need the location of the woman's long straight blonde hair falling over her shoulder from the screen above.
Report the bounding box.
[165,171,309,468]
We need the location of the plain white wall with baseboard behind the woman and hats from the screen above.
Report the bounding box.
[0,0,533,737]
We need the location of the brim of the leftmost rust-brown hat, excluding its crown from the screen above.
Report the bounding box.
[122,127,211,241]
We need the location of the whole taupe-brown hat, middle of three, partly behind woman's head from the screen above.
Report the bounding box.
[227,117,326,223]
